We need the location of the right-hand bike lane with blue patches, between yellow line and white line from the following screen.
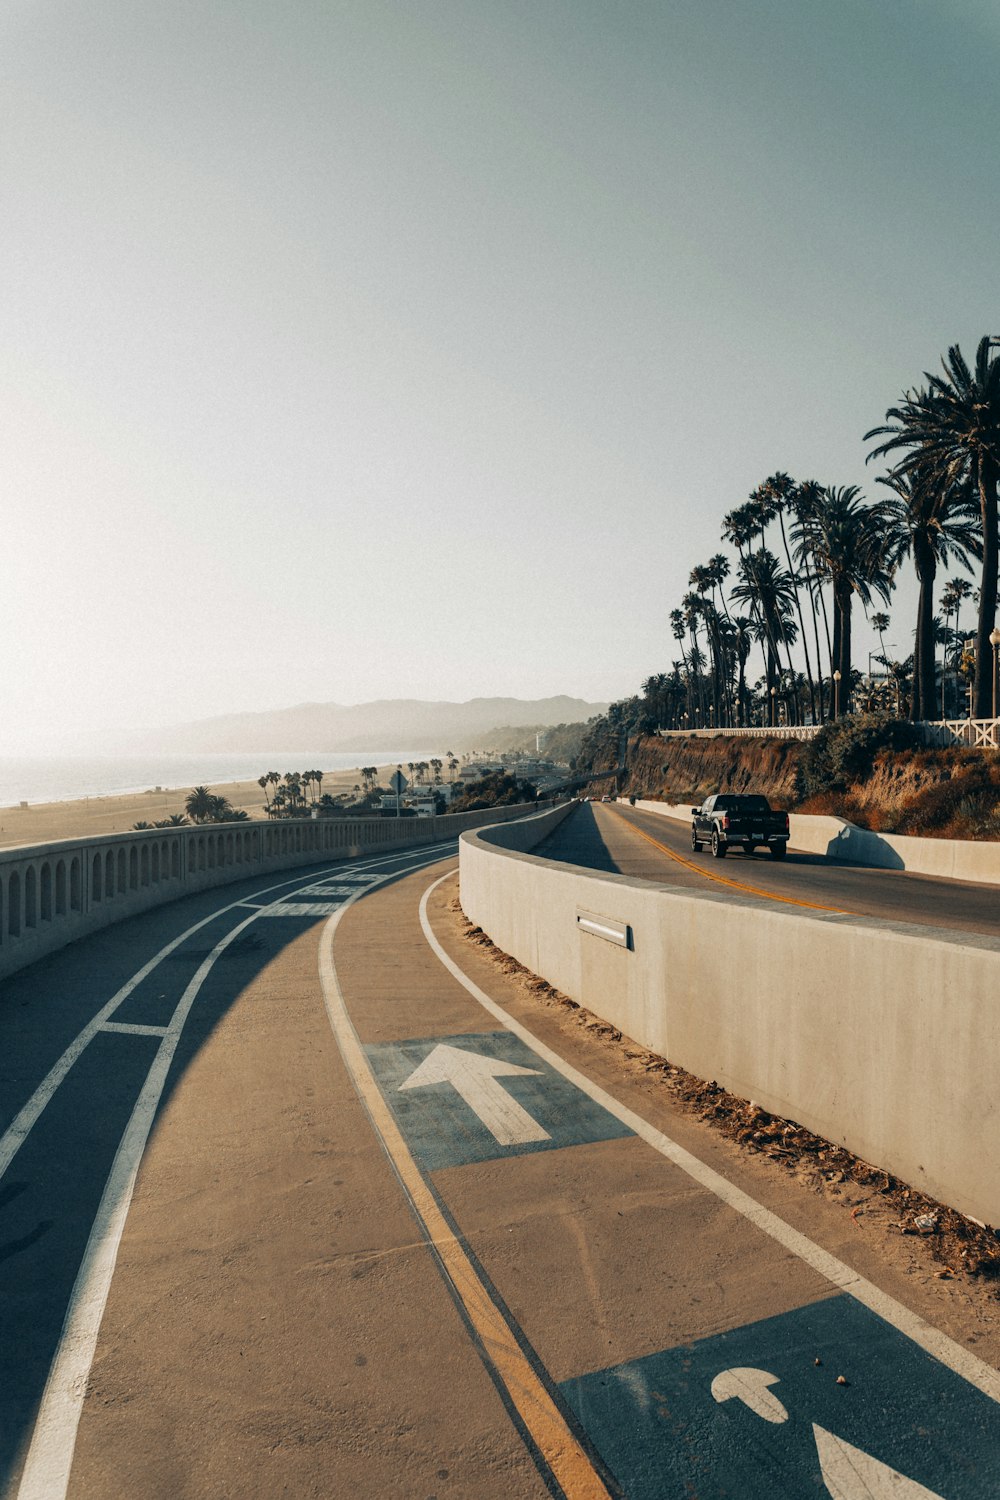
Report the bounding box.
[334,864,1000,1500]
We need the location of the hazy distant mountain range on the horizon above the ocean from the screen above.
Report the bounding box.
[132,696,607,755]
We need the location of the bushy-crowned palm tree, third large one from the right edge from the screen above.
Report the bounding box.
[793,485,892,714]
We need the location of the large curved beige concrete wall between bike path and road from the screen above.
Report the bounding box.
[460,810,1000,1224]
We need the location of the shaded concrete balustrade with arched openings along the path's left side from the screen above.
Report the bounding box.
[0,804,547,980]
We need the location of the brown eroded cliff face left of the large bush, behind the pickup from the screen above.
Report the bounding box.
[624,735,802,807]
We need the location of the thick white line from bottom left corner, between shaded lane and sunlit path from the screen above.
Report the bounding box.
[16,849,452,1500]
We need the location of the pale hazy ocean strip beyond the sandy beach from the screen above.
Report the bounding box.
[0,750,444,807]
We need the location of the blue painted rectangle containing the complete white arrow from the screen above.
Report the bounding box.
[364,1031,633,1172]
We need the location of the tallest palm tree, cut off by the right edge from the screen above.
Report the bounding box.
[865,338,1000,719]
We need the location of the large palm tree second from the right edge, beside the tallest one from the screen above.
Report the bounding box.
[879,467,982,720]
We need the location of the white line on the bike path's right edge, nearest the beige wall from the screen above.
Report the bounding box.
[420,872,1000,1401]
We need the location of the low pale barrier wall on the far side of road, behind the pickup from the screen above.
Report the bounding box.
[629,798,1000,885]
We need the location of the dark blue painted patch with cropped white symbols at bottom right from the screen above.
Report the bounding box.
[561,1295,1000,1500]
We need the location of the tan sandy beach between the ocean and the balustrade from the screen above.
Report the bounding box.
[0,765,396,849]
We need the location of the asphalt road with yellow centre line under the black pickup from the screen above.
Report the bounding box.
[535,803,1000,938]
